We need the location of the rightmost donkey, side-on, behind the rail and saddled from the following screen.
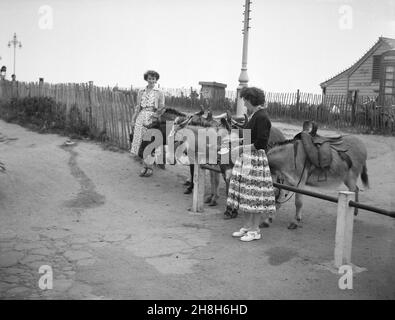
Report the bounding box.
[267,135,369,230]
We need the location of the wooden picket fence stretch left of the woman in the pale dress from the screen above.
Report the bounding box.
[0,80,135,149]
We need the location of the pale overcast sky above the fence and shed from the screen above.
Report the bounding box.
[0,0,395,92]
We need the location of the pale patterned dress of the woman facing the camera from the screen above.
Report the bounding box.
[130,89,159,156]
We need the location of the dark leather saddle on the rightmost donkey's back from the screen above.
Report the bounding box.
[295,121,352,170]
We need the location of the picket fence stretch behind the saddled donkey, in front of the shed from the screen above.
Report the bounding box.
[266,91,395,134]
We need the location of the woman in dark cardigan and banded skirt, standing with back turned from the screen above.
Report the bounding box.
[227,87,276,241]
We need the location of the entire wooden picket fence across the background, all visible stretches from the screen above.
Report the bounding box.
[0,80,395,149]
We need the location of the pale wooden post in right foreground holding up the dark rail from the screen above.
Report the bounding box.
[335,191,355,268]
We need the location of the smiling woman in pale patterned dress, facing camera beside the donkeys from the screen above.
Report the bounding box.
[130,70,165,177]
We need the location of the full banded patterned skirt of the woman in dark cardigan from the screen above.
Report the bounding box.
[227,150,276,216]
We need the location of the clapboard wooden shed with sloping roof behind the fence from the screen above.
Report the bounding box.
[320,37,395,104]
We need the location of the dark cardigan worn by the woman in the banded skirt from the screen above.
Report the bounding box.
[246,109,272,151]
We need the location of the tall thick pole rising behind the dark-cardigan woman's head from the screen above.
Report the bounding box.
[236,0,251,116]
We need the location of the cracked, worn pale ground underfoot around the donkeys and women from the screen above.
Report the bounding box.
[0,121,395,299]
